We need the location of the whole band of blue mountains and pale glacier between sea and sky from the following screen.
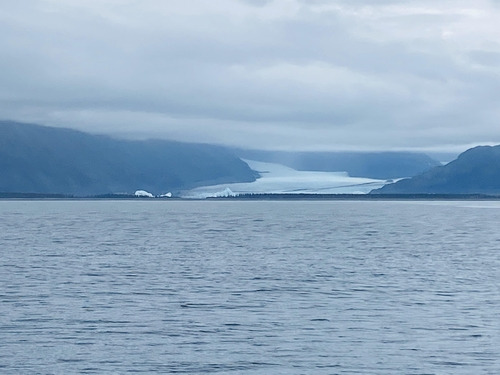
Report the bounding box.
[4,121,500,198]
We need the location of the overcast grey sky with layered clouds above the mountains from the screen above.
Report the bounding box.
[0,0,500,150]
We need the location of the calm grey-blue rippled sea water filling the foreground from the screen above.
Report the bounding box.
[0,201,500,375]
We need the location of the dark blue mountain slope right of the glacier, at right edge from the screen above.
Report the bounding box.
[372,146,500,194]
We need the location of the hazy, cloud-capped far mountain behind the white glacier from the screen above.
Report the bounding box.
[235,150,441,179]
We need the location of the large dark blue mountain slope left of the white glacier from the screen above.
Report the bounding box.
[0,121,256,195]
